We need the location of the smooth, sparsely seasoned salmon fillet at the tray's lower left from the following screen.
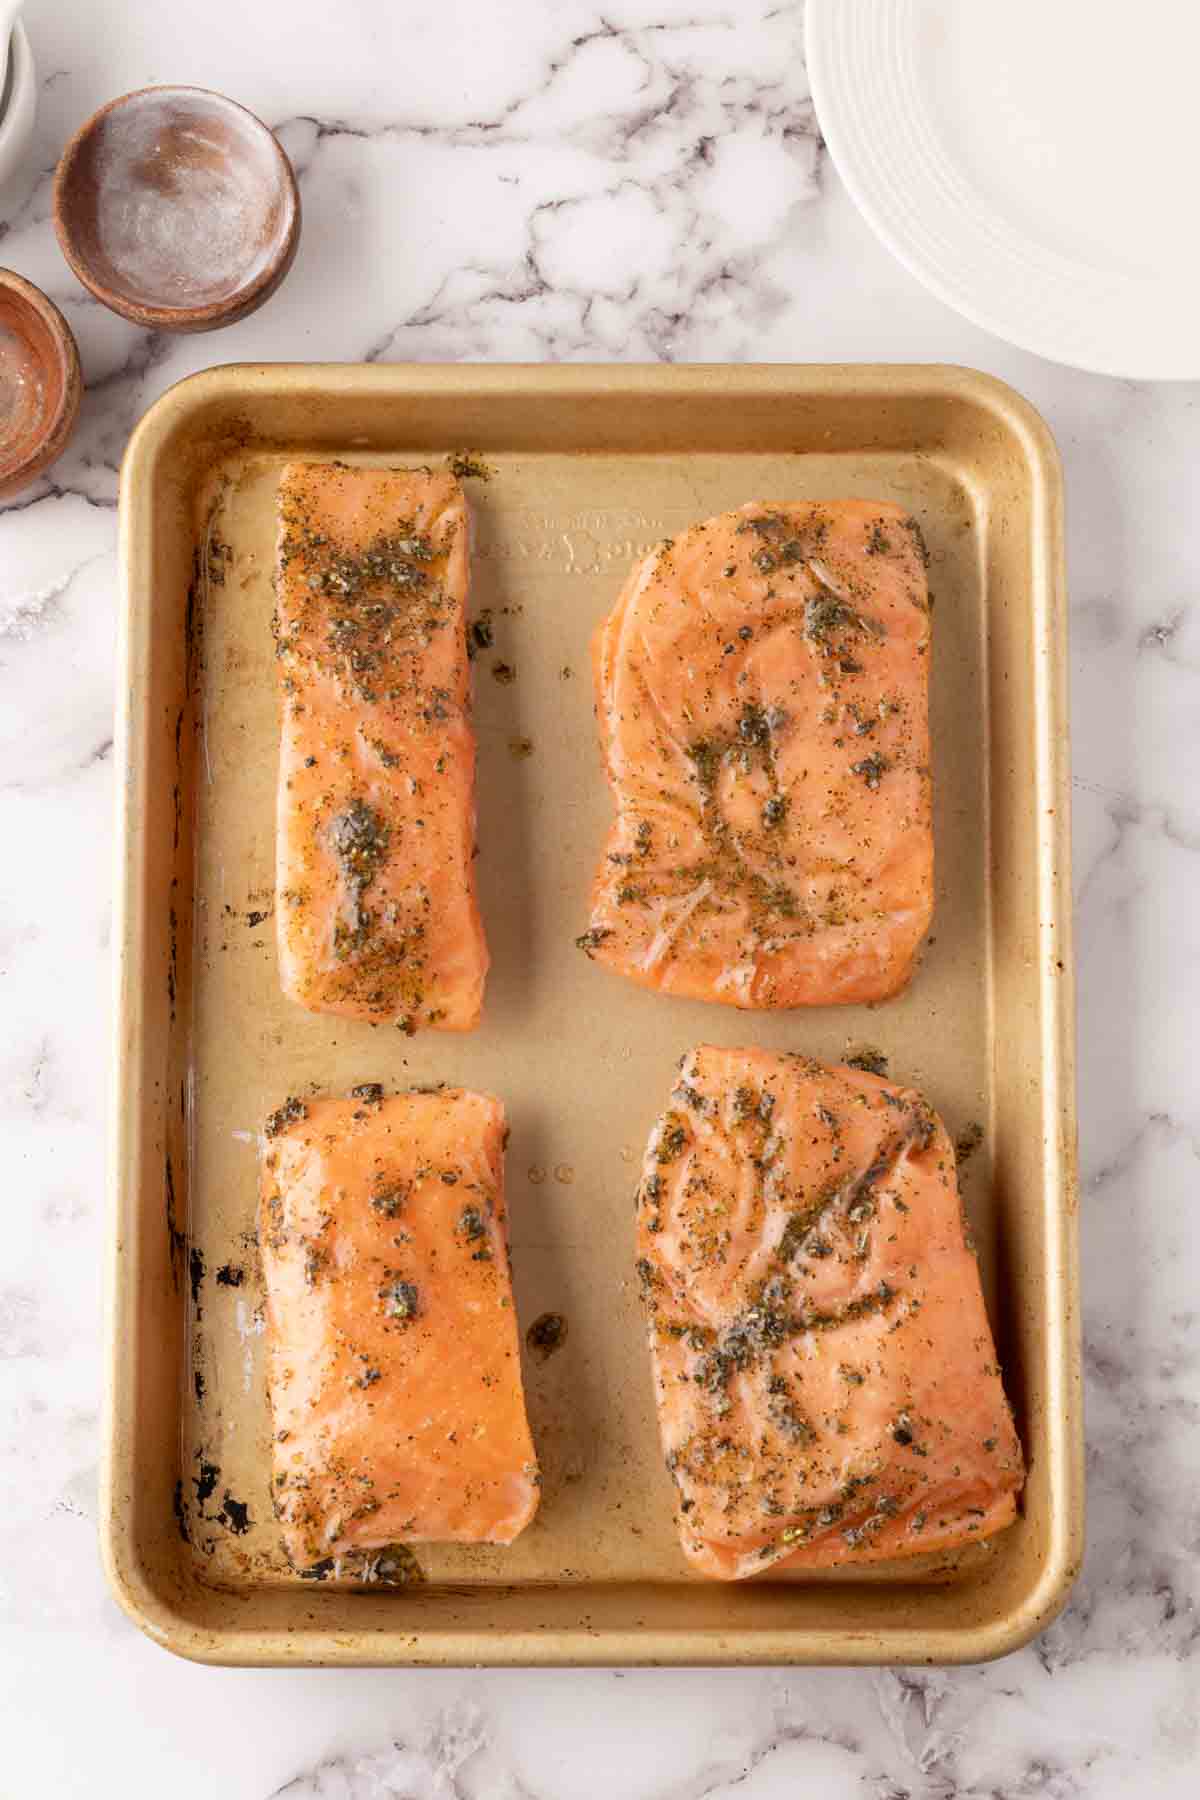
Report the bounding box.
[259,1085,540,1568]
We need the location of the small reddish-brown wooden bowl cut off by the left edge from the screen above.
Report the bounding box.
[0,268,83,500]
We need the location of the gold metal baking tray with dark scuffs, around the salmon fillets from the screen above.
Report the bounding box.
[104,365,1081,1663]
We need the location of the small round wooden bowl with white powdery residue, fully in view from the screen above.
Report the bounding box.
[54,88,300,331]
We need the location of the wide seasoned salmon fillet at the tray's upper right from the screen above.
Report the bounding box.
[579,500,934,1008]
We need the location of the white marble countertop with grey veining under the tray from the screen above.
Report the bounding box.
[0,0,1200,1800]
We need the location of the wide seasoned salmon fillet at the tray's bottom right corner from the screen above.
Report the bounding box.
[637,1046,1024,1580]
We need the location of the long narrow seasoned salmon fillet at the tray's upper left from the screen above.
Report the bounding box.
[275,463,488,1031]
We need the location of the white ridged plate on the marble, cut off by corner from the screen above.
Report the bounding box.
[806,0,1200,380]
